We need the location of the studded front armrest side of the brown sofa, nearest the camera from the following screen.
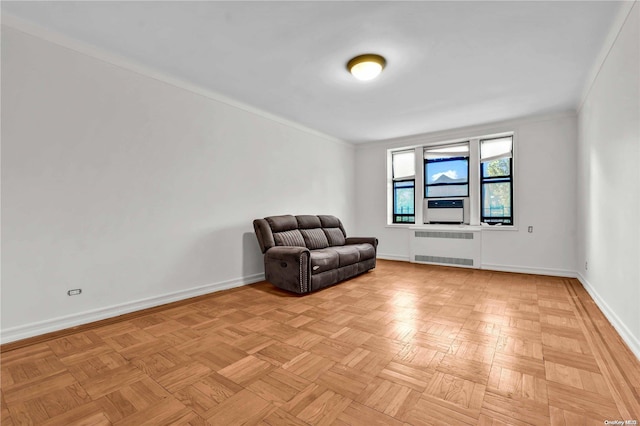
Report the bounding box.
[264,246,311,293]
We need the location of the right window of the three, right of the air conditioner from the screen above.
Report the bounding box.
[480,136,513,225]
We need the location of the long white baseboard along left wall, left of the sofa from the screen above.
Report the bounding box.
[0,273,264,344]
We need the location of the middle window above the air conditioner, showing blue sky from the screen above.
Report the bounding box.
[424,142,469,198]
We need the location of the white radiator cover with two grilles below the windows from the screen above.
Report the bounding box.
[409,228,482,268]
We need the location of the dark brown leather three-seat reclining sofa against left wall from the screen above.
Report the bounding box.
[253,215,378,294]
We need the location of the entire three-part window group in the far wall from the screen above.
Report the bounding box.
[386,131,517,230]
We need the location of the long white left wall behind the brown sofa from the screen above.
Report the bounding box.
[2,25,355,342]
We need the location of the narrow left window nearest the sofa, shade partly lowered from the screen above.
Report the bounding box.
[392,150,416,223]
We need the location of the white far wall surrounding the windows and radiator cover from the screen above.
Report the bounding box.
[356,113,577,276]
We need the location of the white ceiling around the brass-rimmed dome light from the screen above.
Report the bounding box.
[2,1,620,142]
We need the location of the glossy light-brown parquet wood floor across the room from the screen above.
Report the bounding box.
[1,261,640,426]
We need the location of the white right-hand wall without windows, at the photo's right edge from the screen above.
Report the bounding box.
[577,2,640,358]
